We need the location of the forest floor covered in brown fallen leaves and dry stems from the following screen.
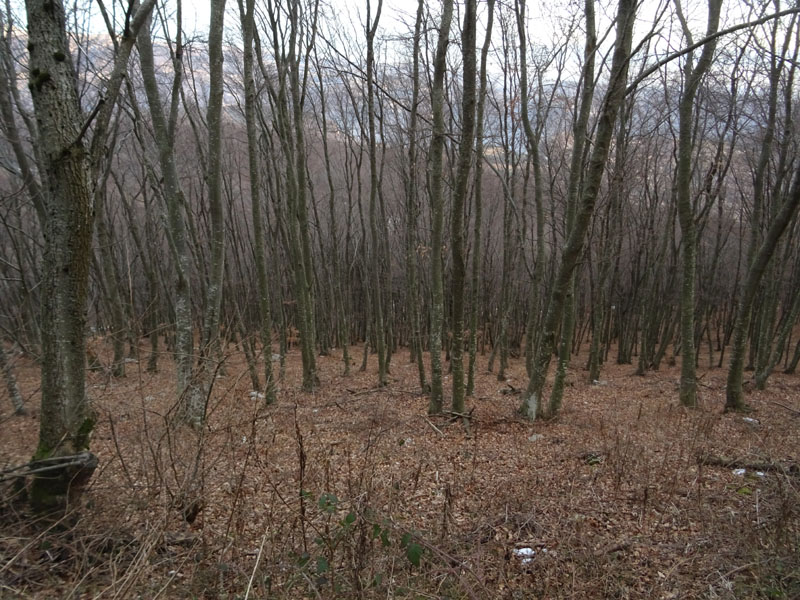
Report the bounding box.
[0,348,800,599]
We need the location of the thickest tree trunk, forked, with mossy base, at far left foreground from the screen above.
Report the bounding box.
[26,0,154,508]
